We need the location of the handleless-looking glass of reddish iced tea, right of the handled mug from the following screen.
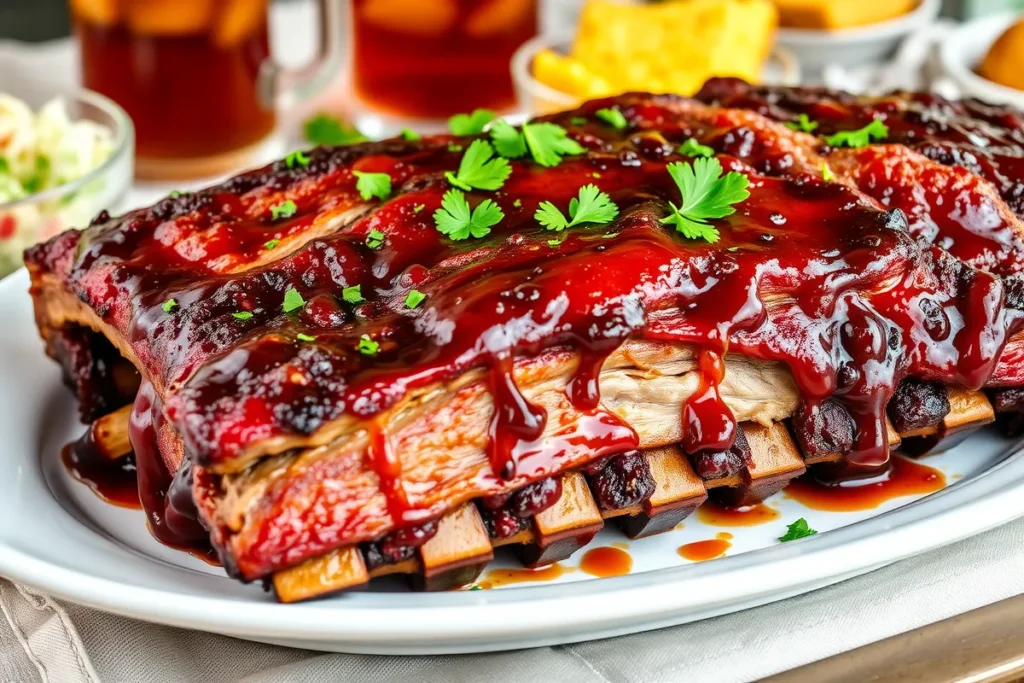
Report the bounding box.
[350,0,538,135]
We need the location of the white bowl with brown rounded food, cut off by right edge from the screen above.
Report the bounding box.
[939,13,1024,109]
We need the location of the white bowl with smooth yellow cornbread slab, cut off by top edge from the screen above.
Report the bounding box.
[775,0,942,73]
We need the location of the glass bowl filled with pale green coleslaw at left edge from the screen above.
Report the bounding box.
[0,90,135,278]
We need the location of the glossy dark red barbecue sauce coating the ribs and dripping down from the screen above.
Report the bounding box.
[27,88,1018,557]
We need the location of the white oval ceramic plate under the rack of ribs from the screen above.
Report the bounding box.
[0,270,1024,654]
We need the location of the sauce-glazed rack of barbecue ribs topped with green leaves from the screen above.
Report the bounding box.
[26,81,1024,601]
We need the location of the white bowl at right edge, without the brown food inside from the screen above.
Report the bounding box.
[939,12,1024,110]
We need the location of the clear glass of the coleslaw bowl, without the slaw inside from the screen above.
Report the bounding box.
[0,90,135,278]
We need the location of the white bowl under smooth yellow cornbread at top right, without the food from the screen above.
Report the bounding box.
[775,0,942,73]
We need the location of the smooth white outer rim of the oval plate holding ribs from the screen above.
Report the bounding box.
[0,269,1024,653]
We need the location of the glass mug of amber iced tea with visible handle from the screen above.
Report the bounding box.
[70,0,343,179]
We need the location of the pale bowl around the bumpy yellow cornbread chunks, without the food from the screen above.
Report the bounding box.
[511,35,800,115]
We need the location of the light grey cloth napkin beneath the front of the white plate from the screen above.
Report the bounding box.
[6,520,1024,683]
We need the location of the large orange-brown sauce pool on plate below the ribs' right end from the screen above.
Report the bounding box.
[783,455,946,512]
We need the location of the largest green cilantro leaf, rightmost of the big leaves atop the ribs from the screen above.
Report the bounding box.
[662,157,751,243]
